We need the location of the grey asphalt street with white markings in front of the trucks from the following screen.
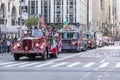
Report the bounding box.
[0,42,120,80]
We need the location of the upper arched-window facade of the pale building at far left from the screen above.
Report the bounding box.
[0,0,19,26]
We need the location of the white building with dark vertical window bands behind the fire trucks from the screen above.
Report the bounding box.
[28,0,87,29]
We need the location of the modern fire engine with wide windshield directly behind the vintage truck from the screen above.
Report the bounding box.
[59,25,87,52]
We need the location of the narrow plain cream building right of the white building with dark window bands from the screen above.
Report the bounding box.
[89,0,102,32]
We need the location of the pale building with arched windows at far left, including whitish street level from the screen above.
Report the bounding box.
[0,0,27,39]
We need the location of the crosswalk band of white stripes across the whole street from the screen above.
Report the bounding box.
[0,61,120,68]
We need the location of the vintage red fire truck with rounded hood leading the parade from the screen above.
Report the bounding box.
[11,29,58,60]
